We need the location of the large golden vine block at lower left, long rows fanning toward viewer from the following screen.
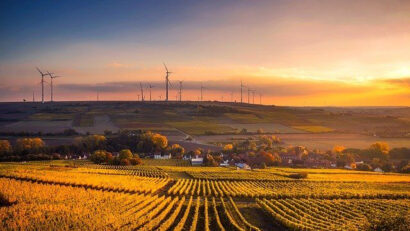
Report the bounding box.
[0,178,259,231]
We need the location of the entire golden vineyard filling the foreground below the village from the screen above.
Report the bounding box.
[0,162,410,231]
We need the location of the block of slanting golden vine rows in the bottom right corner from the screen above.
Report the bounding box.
[256,198,410,231]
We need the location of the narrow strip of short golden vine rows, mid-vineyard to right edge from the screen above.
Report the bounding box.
[167,179,410,199]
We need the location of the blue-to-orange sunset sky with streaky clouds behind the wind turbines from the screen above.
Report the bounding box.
[0,0,410,106]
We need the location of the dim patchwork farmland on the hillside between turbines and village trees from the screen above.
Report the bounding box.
[0,102,410,149]
